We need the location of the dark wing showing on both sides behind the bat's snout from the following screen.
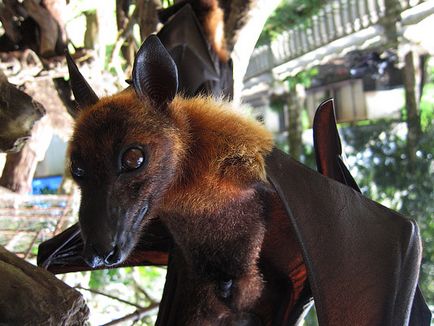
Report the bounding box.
[37,219,173,273]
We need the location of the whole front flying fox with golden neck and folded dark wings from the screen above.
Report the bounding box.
[39,36,429,325]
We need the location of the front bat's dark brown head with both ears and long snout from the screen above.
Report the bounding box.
[67,36,182,267]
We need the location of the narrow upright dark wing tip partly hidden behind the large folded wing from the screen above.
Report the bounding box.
[313,99,431,326]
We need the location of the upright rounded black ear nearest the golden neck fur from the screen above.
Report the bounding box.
[132,35,178,107]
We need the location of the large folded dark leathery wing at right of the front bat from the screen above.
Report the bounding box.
[266,149,421,326]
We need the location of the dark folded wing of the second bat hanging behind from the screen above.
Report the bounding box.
[157,3,233,97]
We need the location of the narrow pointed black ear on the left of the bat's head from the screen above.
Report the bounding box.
[65,50,99,118]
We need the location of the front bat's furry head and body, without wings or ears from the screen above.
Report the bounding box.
[70,38,306,325]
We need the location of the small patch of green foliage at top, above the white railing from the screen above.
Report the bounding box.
[258,0,323,45]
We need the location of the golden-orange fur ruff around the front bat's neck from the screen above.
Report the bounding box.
[161,97,273,216]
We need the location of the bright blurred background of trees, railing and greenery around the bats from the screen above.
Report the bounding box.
[0,0,434,325]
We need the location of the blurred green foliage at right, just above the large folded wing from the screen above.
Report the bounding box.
[341,116,434,304]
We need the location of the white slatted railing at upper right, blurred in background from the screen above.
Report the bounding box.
[244,0,427,80]
